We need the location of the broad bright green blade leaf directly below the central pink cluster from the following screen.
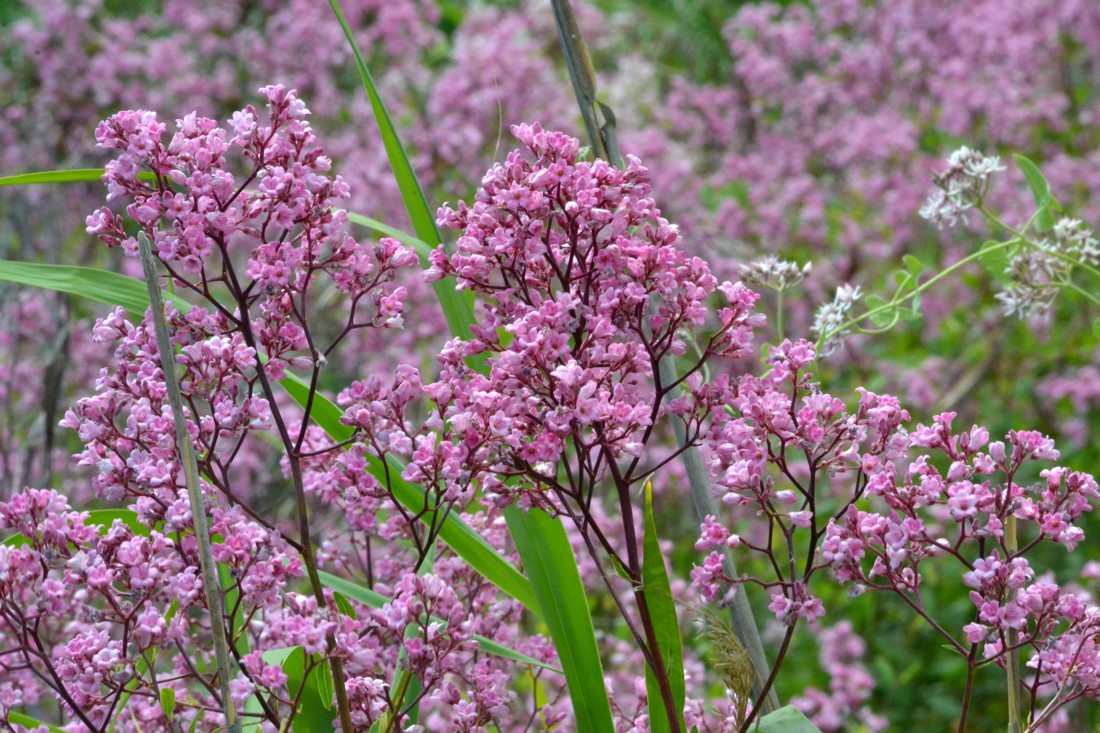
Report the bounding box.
[504,506,615,733]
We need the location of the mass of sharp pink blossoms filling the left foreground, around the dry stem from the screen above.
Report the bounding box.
[0,87,589,731]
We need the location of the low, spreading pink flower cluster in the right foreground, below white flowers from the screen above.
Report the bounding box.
[692,342,1100,716]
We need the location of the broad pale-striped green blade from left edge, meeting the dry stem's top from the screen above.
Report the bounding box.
[0,260,190,318]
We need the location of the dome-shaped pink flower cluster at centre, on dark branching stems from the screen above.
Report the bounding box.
[427,124,762,503]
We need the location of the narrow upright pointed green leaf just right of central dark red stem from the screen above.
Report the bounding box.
[641,482,688,733]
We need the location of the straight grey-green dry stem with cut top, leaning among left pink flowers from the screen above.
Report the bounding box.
[138,237,241,733]
